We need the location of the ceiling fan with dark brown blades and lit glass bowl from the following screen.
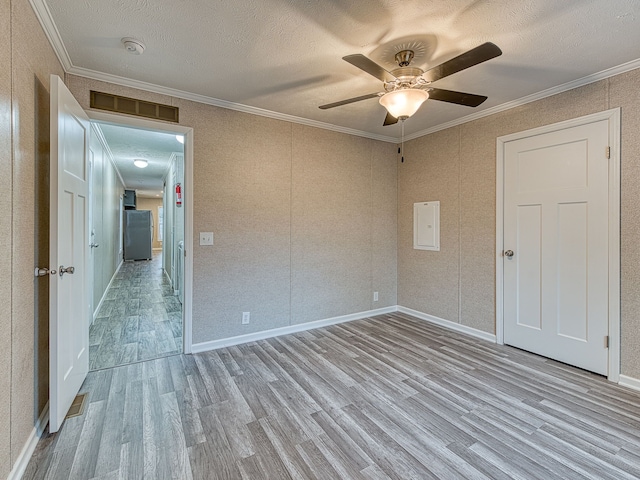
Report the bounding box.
[320,42,502,125]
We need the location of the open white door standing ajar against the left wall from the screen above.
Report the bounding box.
[49,75,89,432]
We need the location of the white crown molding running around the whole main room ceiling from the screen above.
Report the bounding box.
[29,0,640,143]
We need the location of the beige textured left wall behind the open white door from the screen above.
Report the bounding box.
[0,1,63,473]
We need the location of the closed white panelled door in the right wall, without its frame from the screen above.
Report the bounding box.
[503,120,609,374]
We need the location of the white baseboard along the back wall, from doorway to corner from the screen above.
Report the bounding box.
[191,306,398,353]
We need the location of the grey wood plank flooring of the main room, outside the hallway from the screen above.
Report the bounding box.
[24,314,640,480]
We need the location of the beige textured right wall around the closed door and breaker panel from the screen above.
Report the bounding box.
[398,74,640,378]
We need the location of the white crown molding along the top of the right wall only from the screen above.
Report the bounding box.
[404,58,640,141]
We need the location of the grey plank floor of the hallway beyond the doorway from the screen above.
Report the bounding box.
[89,251,182,370]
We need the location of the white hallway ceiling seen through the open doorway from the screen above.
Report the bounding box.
[99,124,183,197]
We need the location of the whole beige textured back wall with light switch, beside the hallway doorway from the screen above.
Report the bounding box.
[67,75,397,343]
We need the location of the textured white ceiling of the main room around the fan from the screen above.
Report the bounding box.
[36,0,640,138]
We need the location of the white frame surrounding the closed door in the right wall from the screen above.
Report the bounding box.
[495,108,621,383]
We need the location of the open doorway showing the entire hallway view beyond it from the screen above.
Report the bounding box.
[89,120,187,370]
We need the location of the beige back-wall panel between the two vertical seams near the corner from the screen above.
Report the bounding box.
[291,125,370,324]
